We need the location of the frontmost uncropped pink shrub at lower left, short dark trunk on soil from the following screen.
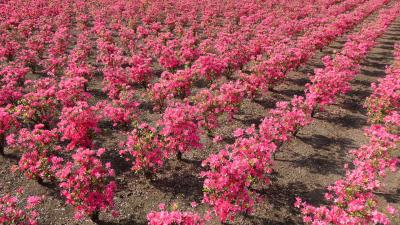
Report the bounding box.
[56,148,117,220]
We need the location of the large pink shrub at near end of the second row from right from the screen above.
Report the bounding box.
[201,135,276,222]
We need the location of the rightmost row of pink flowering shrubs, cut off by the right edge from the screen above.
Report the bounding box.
[296,42,400,224]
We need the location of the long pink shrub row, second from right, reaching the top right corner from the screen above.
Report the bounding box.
[198,3,400,221]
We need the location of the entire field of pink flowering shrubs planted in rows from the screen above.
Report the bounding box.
[0,0,400,225]
